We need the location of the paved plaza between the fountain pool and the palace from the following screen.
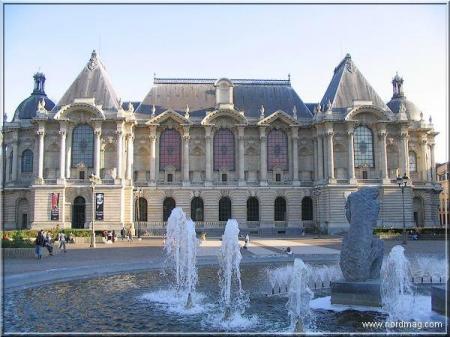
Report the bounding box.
[3,236,445,289]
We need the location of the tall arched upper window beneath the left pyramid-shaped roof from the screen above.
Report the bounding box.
[72,124,94,167]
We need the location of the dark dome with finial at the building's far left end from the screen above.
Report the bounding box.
[13,73,55,121]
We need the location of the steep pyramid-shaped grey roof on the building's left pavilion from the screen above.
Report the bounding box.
[54,50,119,111]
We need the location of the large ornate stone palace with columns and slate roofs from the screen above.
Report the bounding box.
[2,51,440,233]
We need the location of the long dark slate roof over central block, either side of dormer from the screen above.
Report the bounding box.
[136,78,312,118]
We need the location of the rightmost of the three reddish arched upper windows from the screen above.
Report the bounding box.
[267,129,288,171]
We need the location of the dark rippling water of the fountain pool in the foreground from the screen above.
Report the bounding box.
[4,264,445,332]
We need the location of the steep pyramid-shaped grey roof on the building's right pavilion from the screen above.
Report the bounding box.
[320,54,389,113]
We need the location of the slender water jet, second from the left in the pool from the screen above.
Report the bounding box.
[219,219,247,320]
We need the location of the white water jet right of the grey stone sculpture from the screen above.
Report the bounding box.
[381,245,414,321]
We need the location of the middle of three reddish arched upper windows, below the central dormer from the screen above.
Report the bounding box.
[214,129,234,171]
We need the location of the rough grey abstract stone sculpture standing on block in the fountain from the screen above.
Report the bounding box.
[339,187,384,281]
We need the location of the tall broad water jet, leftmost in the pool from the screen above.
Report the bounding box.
[164,207,198,309]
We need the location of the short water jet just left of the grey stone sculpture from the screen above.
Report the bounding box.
[287,259,313,332]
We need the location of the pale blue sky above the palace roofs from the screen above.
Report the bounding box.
[4,4,448,162]
